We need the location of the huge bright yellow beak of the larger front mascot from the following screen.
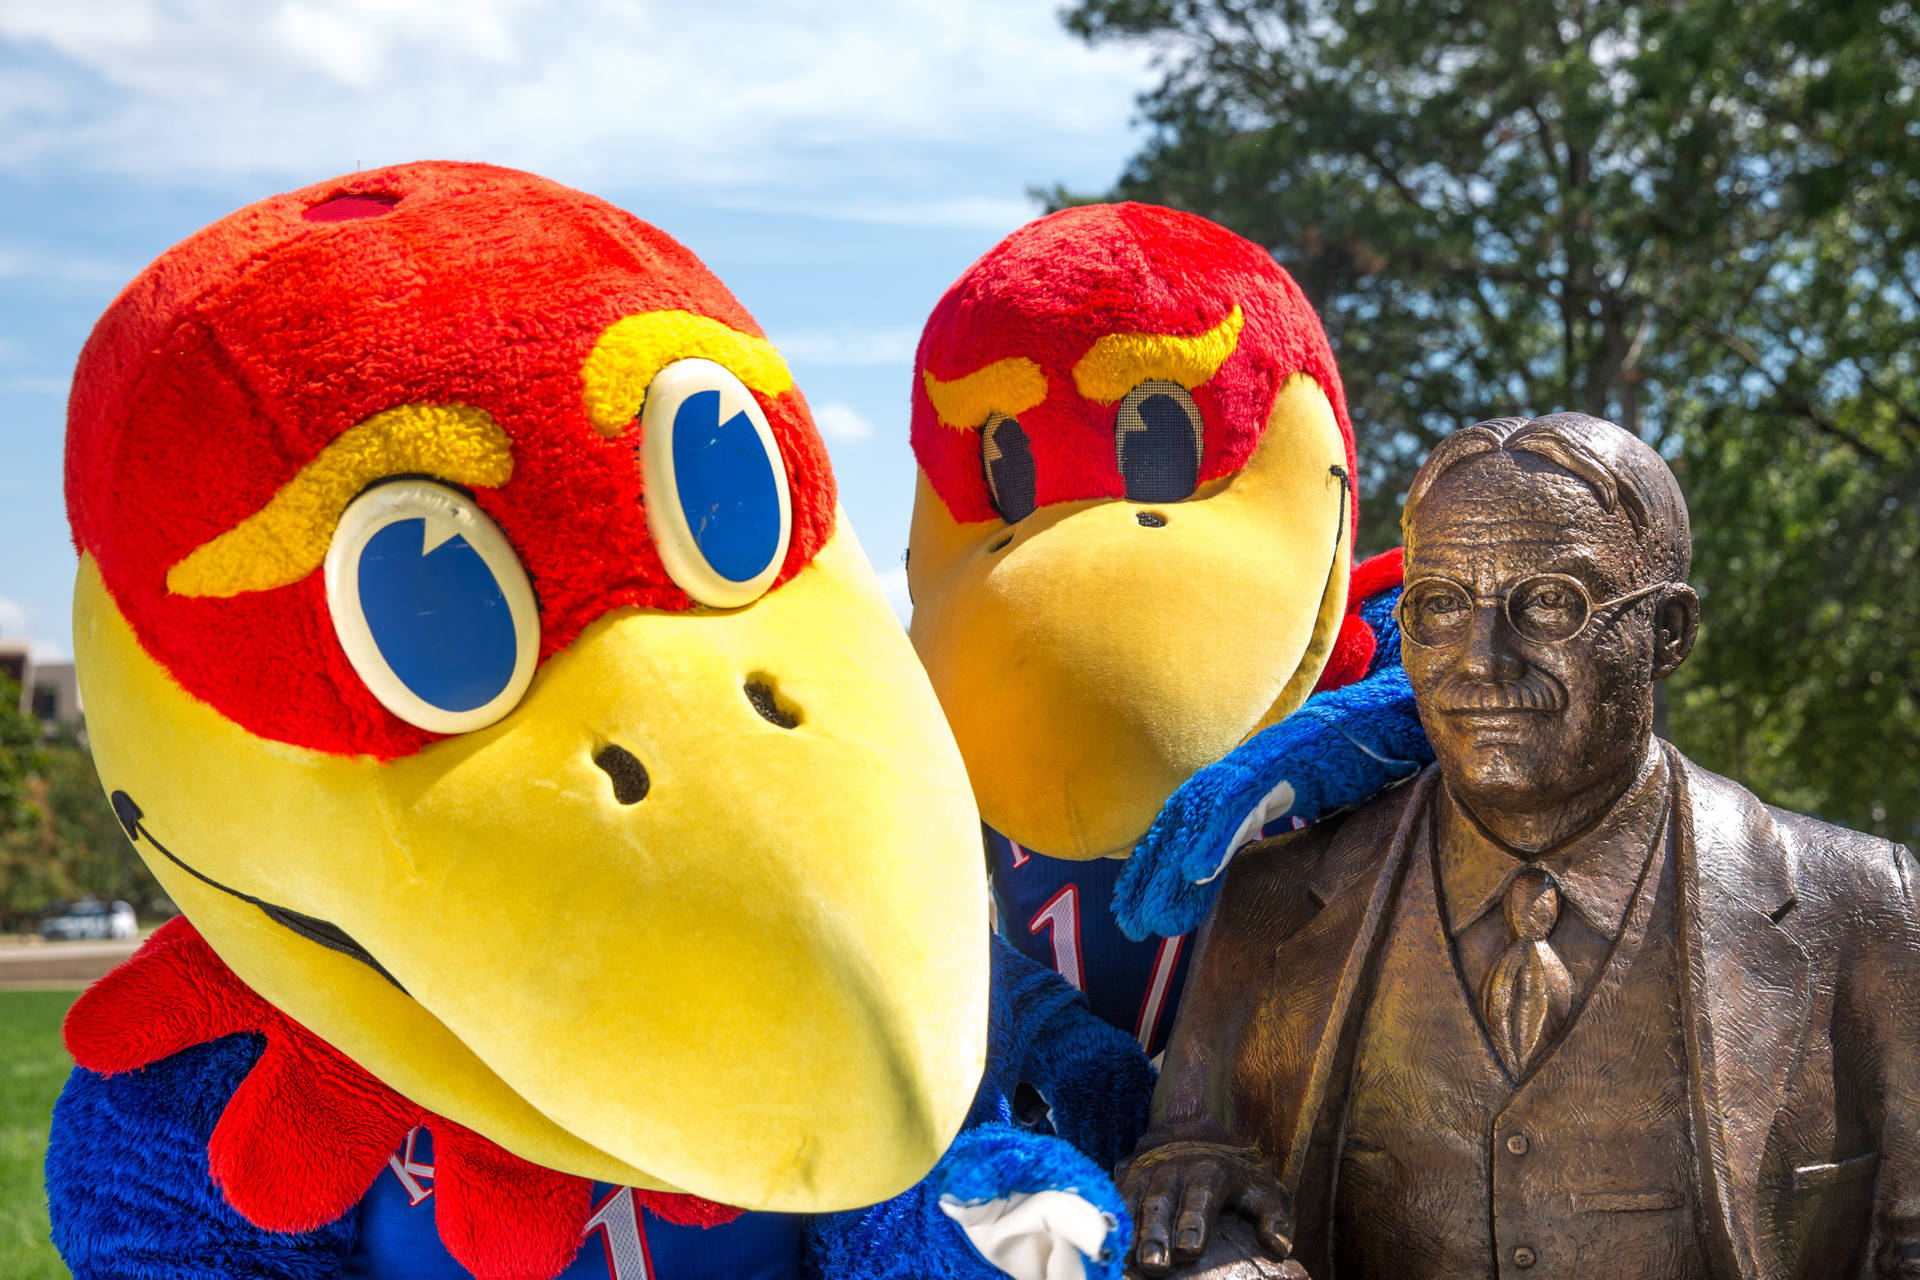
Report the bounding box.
[75,526,987,1211]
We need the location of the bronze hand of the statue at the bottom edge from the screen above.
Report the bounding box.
[1119,1142,1294,1276]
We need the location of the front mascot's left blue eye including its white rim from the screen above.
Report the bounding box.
[326,480,540,733]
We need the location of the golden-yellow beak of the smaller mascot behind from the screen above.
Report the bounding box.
[908,374,1352,858]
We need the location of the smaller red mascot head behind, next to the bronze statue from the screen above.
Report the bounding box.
[908,203,1354,858]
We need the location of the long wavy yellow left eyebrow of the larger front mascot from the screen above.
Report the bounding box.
[167,405,513,597]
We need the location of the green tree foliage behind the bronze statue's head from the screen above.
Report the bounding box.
[1054,0,1920,837]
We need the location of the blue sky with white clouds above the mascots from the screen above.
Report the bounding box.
[0,0,1152,656]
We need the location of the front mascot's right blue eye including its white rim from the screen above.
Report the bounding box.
[639,359,793,608]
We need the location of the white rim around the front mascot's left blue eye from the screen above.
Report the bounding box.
[324,480,540,733]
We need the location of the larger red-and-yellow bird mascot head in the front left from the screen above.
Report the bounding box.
[67,163,987,1211]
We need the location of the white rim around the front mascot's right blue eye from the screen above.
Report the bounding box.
[639,357,793,608]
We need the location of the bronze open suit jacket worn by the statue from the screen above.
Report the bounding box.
[1140,747,1920,1280]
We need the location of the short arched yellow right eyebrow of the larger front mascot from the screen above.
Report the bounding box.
[582,311,793,439]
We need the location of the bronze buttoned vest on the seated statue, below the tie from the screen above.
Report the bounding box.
[1334,817,1711,1280]
